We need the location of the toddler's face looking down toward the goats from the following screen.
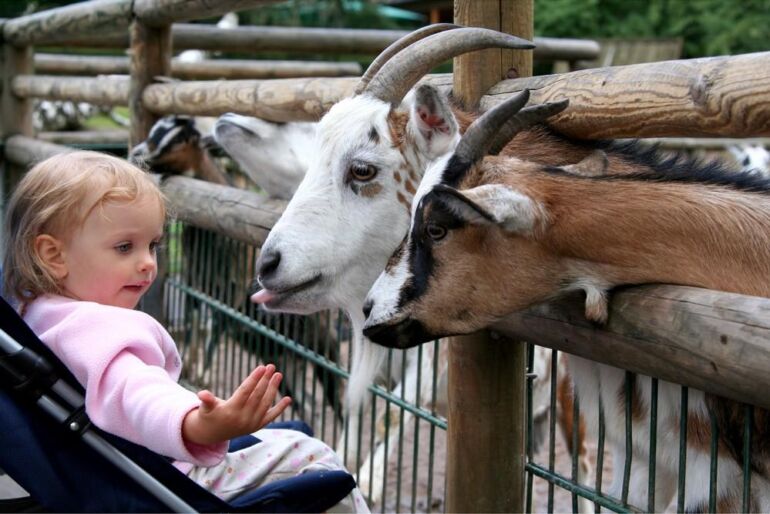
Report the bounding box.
[62,198,164,309]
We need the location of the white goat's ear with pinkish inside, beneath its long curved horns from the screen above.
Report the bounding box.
[409,84,459,159]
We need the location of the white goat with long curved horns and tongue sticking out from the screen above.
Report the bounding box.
[253,25,588,501]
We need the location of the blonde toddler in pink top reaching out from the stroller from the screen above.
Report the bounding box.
[3,151,368,512]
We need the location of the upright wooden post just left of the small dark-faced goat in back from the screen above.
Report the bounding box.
[128,20,171,325]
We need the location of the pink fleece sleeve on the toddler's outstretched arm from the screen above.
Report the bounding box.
[50,304,227,466]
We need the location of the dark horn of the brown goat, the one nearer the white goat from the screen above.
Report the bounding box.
[454,89,529,163]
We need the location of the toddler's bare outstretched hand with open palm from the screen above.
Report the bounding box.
[182,364,291,444]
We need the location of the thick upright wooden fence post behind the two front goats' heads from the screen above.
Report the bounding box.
[446,0,533,512]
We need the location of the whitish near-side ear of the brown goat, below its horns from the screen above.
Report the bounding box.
[433,184,547,236]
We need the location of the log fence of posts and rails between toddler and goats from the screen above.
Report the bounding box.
[0,0,770,511]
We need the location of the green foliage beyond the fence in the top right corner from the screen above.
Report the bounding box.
[535,0,770,57]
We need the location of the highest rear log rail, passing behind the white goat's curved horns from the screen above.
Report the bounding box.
[52,23,599,61]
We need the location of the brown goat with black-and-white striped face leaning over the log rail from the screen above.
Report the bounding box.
[365,93,770,512]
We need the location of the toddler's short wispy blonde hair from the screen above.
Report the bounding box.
[3,151,166,304]
